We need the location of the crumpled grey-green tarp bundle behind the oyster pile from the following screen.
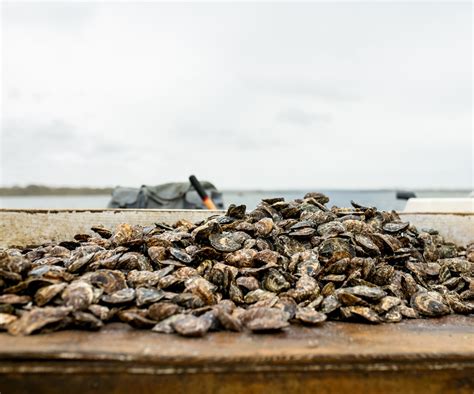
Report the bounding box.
[107,181,224,209]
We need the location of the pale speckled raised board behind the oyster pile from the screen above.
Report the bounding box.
[0,209,474,247]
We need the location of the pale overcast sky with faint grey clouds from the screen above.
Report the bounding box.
[0,2,474,190]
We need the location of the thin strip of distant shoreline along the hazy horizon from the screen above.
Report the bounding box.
[0,185,471,197]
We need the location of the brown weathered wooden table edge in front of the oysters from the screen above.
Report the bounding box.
[0,316,474,394]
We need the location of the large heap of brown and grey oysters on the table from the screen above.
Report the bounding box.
[0,193,474,336]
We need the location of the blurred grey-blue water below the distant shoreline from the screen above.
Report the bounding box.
[0,190,469,210]
